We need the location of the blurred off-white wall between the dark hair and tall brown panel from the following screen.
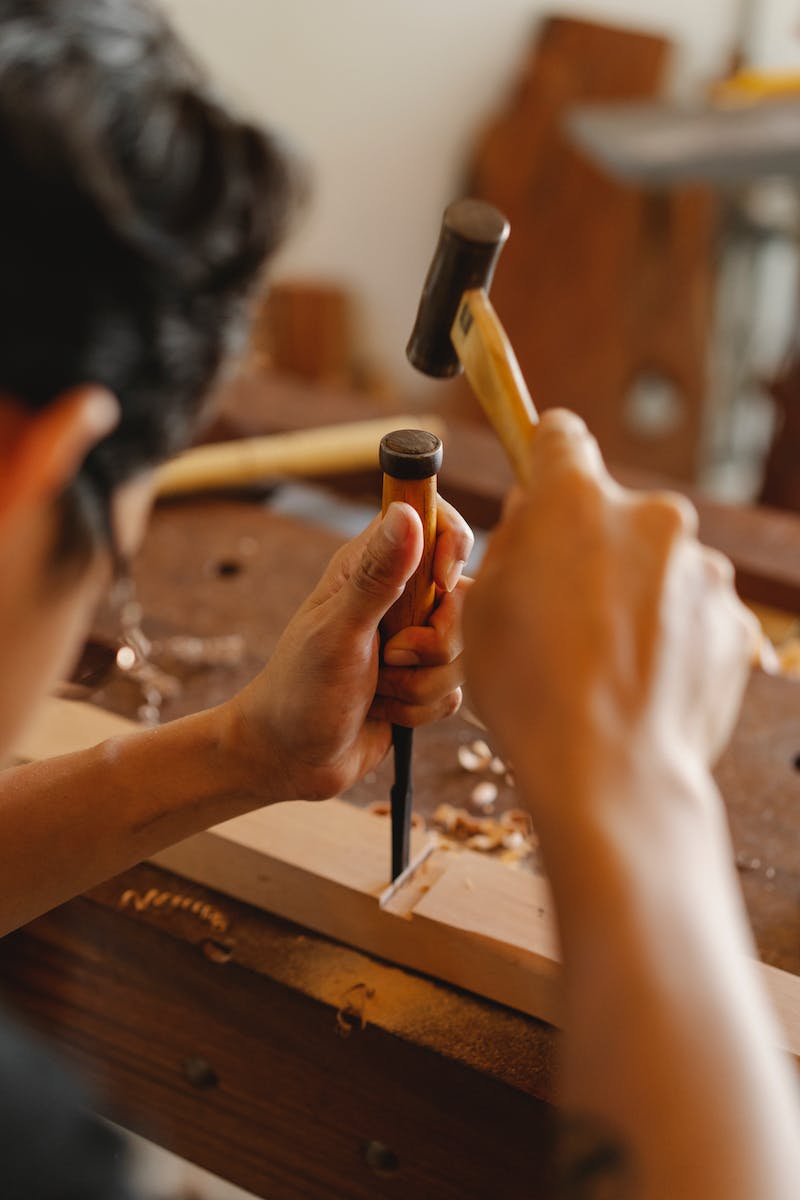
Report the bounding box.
[159,0,748,391]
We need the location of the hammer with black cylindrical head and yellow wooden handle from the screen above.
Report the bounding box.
[405,199,539,482]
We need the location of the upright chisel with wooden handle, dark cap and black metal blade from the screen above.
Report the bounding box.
[380,430,443,880]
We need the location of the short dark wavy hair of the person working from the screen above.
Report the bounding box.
[0,0,302,557]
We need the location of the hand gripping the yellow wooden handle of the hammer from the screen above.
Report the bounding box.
[464,410,758,840]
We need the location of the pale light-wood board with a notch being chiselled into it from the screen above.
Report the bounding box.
[14,700,800,1058]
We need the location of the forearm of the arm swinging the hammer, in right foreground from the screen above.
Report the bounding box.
[520,748,800,1200]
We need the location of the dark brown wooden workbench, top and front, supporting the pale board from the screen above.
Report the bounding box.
[0,405,800,1200]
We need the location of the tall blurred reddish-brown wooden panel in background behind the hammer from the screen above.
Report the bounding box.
[443,17,716,480]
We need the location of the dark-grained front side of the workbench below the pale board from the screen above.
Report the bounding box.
[0,868,554,1200]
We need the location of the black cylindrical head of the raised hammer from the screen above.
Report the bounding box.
[405,200,510,378]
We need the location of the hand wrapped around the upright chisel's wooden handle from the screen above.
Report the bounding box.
[221,499,473,799]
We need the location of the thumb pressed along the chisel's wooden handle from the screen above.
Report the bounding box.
[339,503,422,634]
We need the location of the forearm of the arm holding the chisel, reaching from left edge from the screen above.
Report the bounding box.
[0,707,278,934]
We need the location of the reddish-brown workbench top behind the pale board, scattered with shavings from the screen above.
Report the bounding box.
[86,500,800,931]
